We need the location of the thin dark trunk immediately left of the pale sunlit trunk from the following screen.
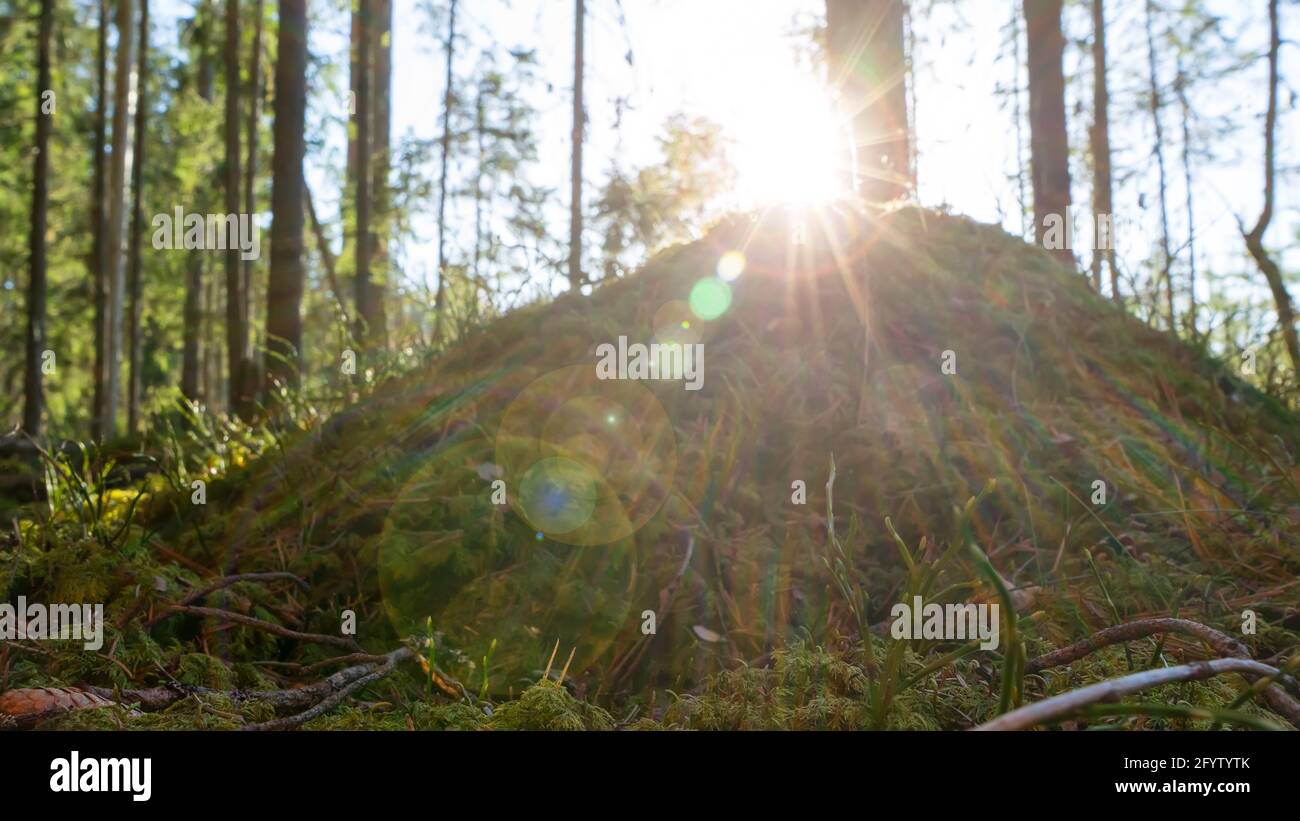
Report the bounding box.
[90,0,108,440]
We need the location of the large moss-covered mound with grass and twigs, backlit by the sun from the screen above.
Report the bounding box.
[0,209,1300,727]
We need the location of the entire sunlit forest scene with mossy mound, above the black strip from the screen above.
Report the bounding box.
[0,0,1300,743]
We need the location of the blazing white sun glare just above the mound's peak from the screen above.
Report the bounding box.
[735,68,848,205]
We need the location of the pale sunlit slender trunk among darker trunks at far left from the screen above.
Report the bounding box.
[103,0,135,438]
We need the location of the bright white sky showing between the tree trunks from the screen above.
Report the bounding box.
[142,0,1300,323]
